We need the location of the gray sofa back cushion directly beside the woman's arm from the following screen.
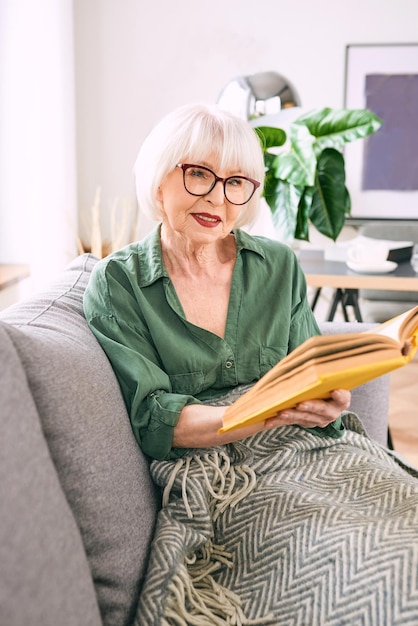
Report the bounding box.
[0,255,158,626]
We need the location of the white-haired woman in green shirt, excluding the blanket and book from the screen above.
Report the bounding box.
[85,106,350,459]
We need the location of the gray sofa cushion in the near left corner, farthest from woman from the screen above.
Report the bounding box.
[0,323,102,626]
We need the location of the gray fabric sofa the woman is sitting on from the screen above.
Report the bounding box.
[0,254,389,626]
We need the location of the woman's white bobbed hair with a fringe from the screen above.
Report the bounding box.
[134,104,265,228]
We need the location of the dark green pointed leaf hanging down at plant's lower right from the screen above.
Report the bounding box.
[309,148,350,241]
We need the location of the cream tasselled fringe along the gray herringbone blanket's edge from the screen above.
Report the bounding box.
[158,448,272,626]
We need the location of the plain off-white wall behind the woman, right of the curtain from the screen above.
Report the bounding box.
[74,0,418,239]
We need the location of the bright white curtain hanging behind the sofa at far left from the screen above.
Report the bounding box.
[0,0,77,287]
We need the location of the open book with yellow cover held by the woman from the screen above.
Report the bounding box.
[219,306,418,432]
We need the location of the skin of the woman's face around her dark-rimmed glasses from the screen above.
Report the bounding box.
[158,157,242,243]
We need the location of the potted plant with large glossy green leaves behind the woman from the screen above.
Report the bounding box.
[254,108,382,241]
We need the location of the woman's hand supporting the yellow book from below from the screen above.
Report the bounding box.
[264,389,351,428]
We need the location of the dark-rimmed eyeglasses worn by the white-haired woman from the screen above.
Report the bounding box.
[176,163,260,205]
